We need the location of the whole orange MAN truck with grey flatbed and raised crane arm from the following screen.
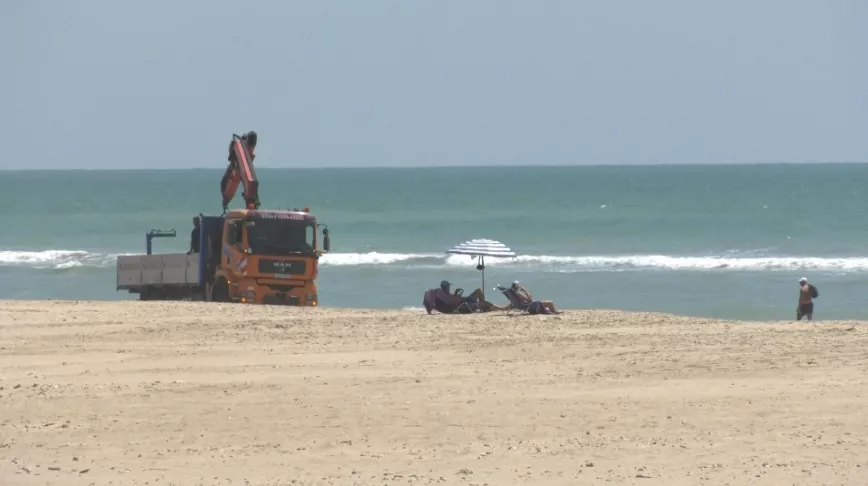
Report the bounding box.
[116,132,331,306]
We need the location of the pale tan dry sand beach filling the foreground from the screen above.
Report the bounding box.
[0,302,868,485]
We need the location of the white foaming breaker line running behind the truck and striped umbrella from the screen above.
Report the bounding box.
[0,250,868,273]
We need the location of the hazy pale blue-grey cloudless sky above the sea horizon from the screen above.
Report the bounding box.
[0,0,868,169]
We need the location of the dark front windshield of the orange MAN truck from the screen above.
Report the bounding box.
[247,220,316,256]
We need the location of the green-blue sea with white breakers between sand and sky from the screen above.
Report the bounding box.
[0,164,868,319]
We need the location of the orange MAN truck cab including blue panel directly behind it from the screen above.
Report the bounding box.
[199,208,331,306]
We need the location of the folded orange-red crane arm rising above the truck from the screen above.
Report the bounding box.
[220,131,259,213]
